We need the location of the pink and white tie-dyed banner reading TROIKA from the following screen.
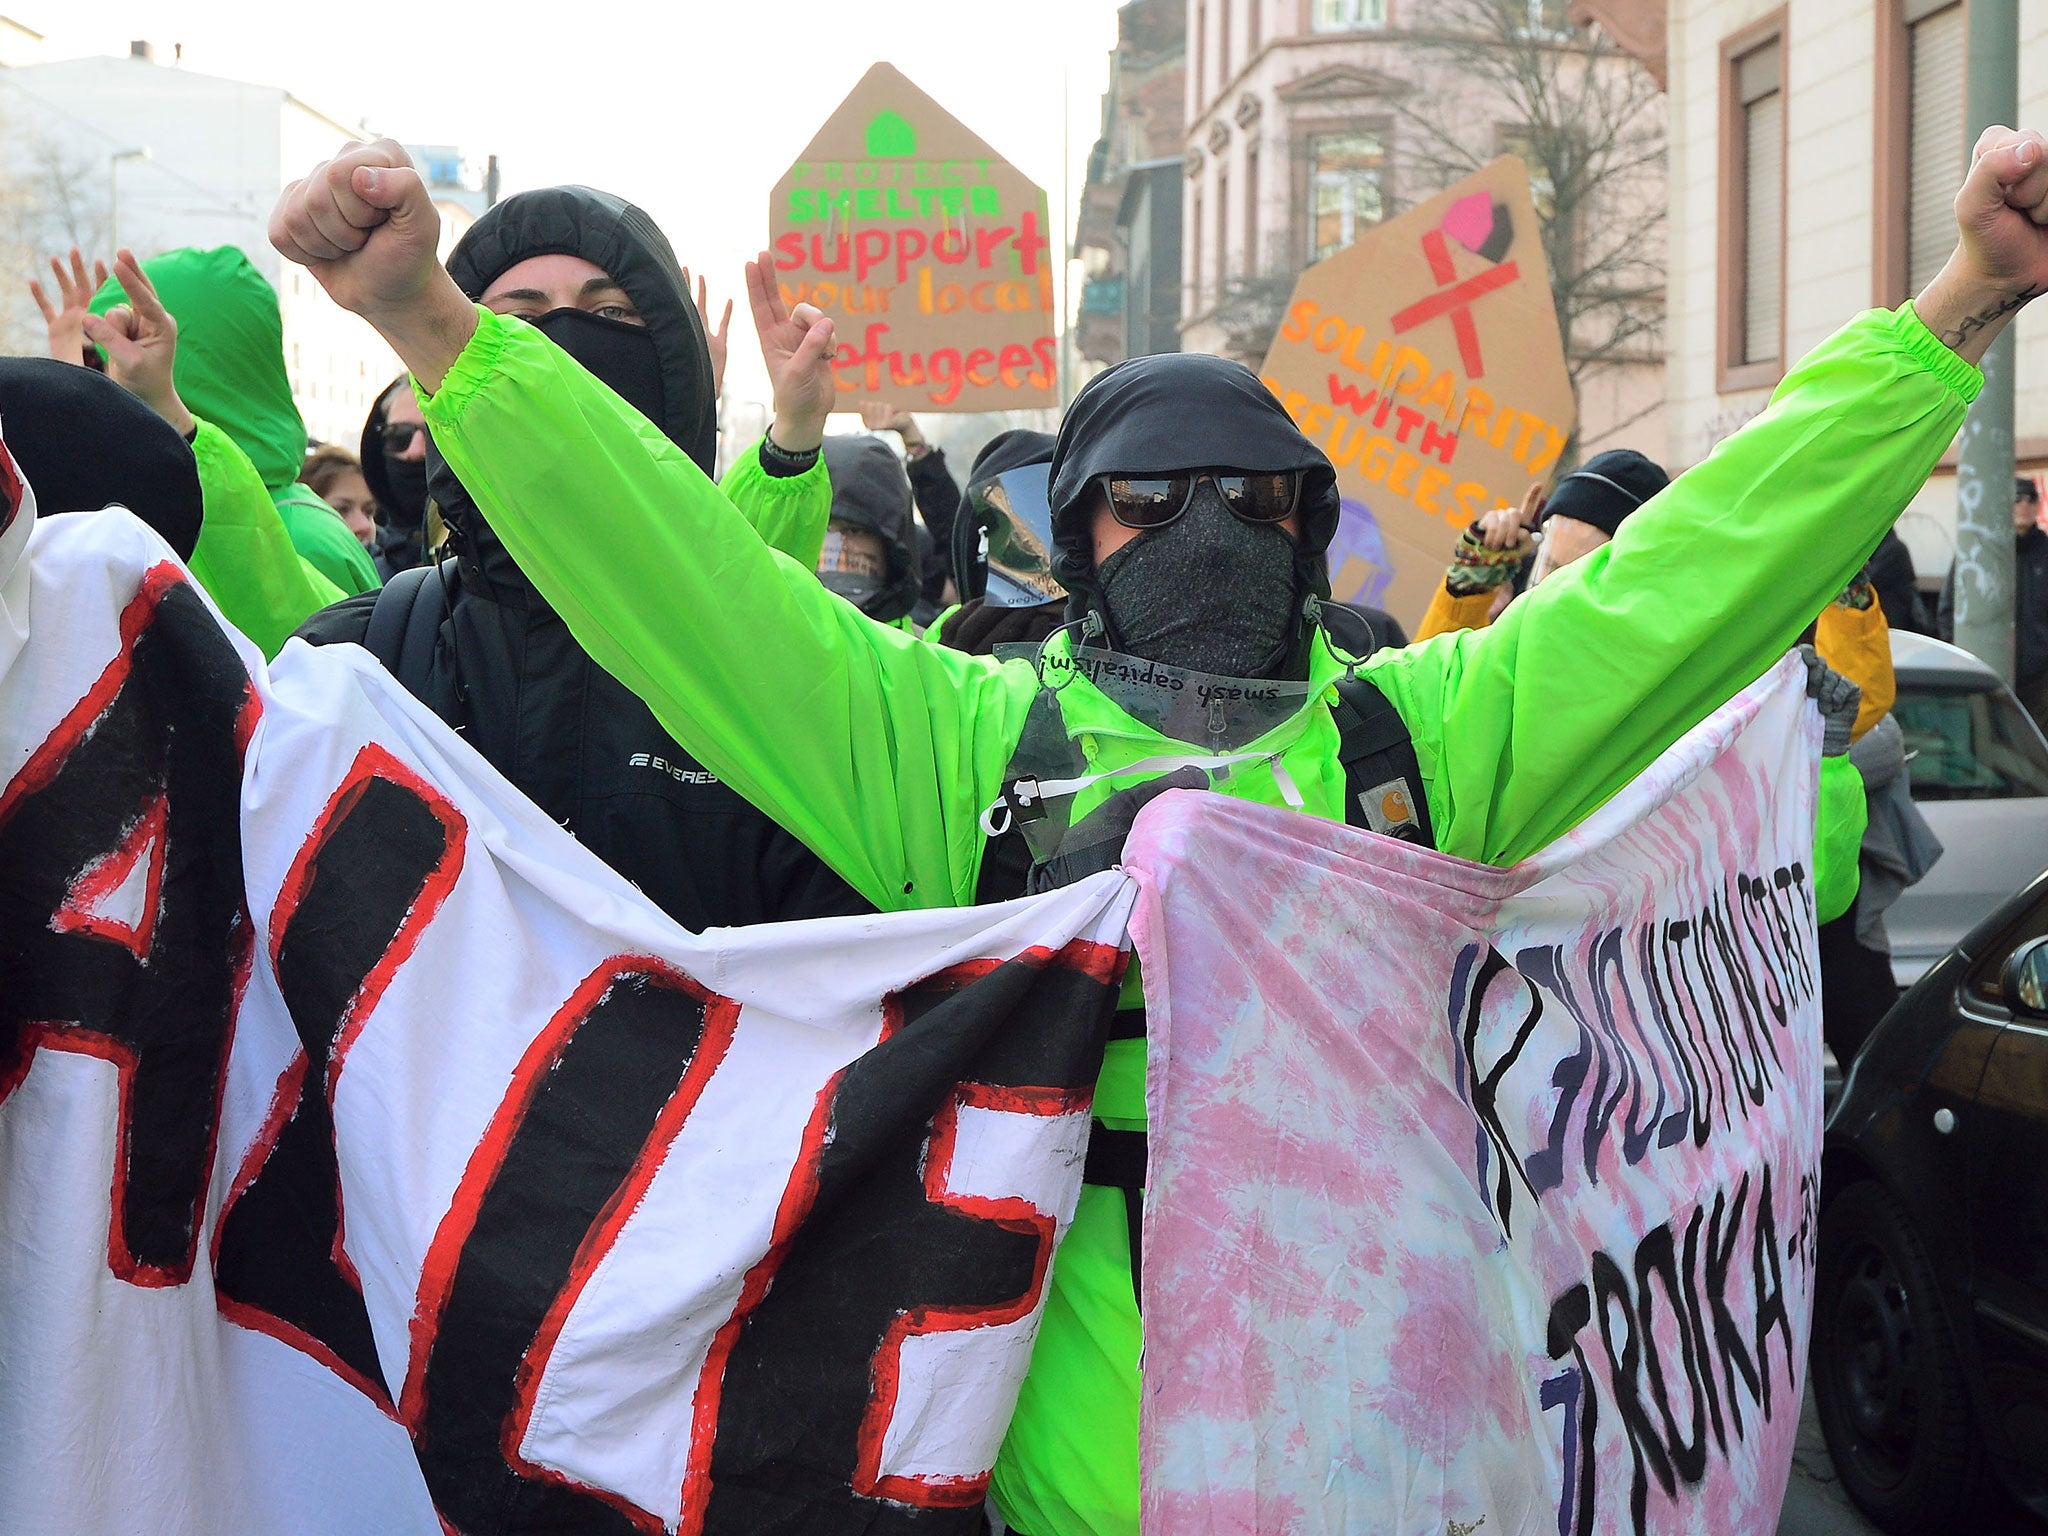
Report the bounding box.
[1126,657,1821,1536]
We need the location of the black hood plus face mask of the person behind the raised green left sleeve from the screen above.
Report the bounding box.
[426,186,719,608]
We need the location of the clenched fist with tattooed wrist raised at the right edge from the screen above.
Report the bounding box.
[1913,127,2048,362]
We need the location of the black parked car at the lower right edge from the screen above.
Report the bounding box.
[1810,874,2048,1536]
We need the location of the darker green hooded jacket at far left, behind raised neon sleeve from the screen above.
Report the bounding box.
[92,246,377,593]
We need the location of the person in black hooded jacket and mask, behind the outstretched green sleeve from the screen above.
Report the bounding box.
[286,172,856,930]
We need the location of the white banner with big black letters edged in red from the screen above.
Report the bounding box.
[0,487,1133,1536]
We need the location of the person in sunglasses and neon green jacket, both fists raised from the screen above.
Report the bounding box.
[270,131,2048,1536]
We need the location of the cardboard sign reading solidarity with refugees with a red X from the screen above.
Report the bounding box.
[1260,156,1577,629]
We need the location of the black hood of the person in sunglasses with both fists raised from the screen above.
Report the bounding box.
[1053,352,1339,676]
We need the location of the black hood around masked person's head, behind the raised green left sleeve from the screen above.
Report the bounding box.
[426,186,719,608]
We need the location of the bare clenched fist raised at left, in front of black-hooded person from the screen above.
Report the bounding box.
[270,139,477,389]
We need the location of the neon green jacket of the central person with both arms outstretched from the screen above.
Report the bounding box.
[424,307,1980,1536]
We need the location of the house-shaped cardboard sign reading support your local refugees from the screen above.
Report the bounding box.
[768,63,1059,412]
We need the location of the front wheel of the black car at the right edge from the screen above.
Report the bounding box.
[1812,1180,1985,1536]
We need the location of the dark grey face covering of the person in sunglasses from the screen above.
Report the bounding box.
[1096,479,1298,678]
